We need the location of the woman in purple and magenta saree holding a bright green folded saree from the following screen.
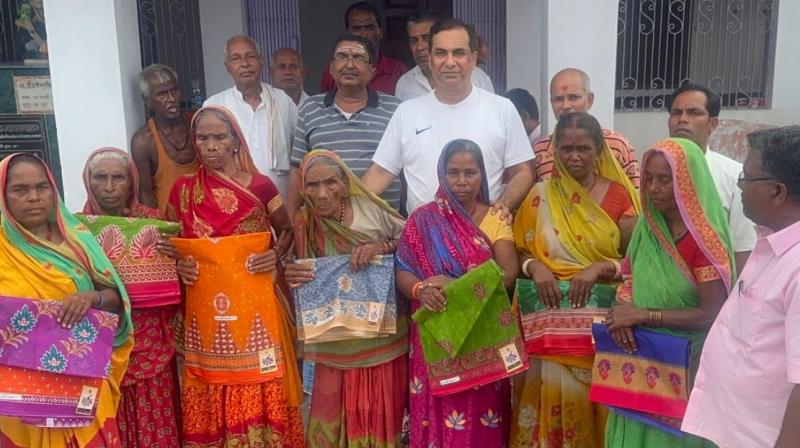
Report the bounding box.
[396,140,519,448]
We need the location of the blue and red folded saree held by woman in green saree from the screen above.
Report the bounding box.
[589,324,691,434]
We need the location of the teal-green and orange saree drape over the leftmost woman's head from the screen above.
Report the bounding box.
[0,153,133,347]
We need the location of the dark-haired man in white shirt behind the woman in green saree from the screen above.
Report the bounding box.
[667,84,757,272]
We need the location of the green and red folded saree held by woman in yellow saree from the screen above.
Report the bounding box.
[515,279,616,356]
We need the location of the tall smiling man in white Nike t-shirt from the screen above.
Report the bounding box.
[364,19,533,214]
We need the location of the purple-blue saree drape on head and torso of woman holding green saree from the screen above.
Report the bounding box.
[397,140,492,279]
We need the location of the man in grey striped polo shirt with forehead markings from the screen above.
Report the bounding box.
[287,34,401,214]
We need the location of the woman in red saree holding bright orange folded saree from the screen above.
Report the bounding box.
[167,106,303,447]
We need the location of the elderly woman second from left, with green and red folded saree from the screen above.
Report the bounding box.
[81,148,181,448]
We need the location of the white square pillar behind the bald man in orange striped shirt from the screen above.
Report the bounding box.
[506,0,619,132]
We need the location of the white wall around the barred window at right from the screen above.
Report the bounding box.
[615,1,800,156]
